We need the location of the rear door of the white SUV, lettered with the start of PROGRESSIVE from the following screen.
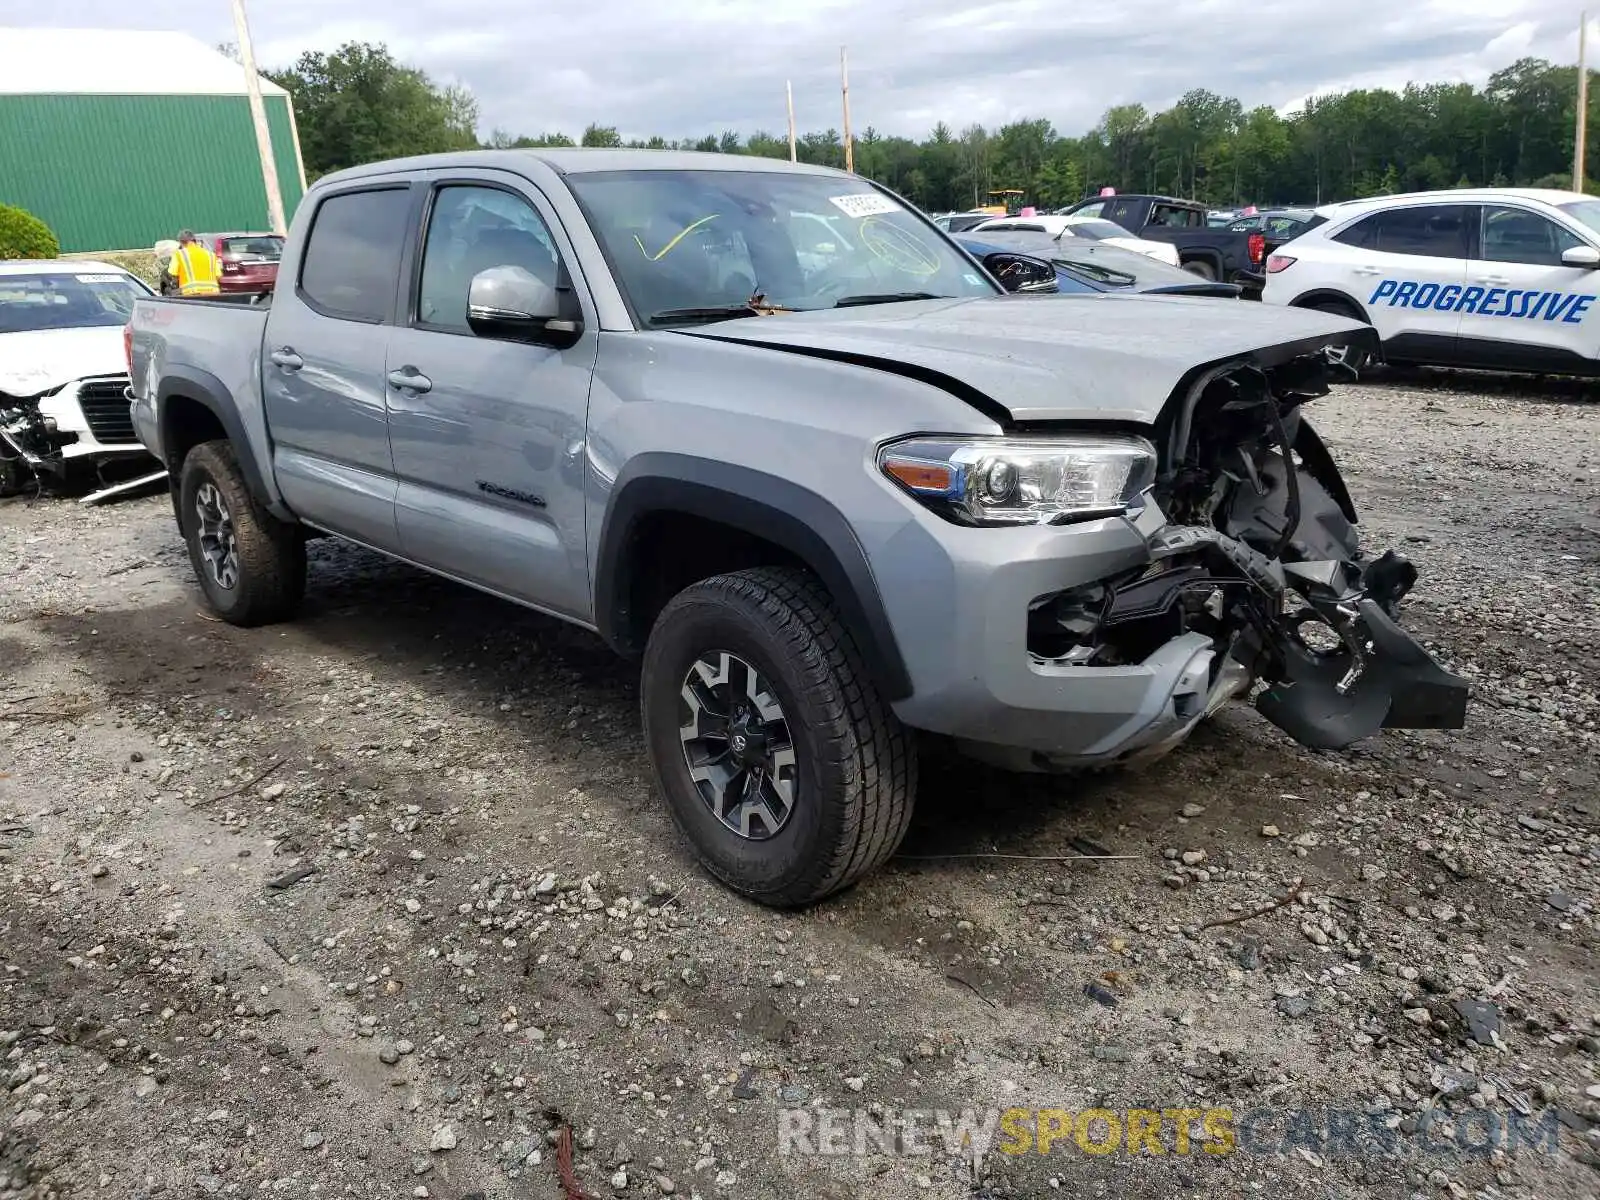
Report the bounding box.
[1322,203,1472,362]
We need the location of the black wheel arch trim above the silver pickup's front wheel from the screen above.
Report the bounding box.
[595,451,912,701]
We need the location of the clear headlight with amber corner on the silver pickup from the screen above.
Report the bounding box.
[878,435,1155,525]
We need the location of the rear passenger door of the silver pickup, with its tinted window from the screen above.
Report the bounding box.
[261,179,419,552]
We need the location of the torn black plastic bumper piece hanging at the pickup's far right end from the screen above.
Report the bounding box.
[1256,598,1469,750]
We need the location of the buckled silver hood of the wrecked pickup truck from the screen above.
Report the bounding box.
[678,294,1376,426]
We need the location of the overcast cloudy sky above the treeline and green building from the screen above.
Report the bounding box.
[0,0,1600,138]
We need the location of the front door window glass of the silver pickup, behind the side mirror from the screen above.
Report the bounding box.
[416,184,558,333]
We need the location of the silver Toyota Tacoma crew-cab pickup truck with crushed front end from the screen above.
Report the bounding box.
[130,150,1466,904]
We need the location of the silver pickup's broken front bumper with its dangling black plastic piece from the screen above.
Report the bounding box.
[890,502,1466,770]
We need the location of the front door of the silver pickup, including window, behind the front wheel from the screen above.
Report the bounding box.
[386,183,598,621]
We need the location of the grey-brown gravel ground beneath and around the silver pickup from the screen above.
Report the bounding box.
[0,374,1600,1200]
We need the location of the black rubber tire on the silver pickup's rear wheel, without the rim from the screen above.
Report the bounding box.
[178,440,306,626]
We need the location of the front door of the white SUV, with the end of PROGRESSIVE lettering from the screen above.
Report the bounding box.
[1459,203,1600,371]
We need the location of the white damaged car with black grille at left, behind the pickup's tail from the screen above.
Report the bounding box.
[0,259,157,494]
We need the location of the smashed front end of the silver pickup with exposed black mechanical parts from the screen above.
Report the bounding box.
[1029,334,1467,765]
